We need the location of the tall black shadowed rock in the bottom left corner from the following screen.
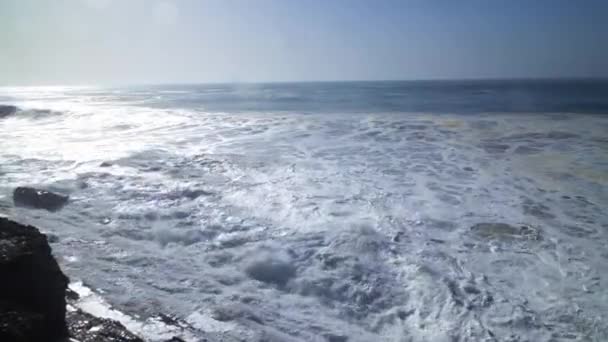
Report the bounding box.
[0,218,68,342]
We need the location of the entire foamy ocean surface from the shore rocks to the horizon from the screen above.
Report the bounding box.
[0,80,608,342]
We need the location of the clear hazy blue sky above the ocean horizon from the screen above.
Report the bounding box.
[0,0,608,85]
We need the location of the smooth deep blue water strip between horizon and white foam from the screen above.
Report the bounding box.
[111,80,608,114]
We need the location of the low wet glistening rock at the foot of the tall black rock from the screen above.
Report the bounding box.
[67,310,143,342]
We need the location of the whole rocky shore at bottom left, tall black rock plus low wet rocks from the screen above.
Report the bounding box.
[0,217,151,342]
